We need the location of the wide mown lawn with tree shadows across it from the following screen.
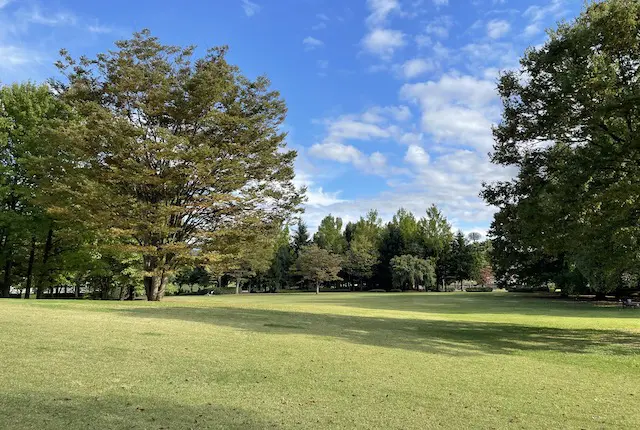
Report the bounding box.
[0,293,640,429]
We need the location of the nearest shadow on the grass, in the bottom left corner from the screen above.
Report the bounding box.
[0,392,272,430]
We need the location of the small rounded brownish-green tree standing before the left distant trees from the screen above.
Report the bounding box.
[295,244,342,294]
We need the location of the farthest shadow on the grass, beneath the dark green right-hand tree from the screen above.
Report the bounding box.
[308,293,640,318]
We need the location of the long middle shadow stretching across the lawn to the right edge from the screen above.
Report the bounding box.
[112,306,640,356]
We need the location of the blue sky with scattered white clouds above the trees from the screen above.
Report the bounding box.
[0,0,582,232]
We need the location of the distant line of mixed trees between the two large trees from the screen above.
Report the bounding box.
[176,206,493,293]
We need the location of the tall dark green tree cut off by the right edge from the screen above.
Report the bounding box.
[484,0,640,294]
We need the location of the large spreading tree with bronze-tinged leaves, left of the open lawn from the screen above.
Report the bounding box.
[55,30,300,300]
